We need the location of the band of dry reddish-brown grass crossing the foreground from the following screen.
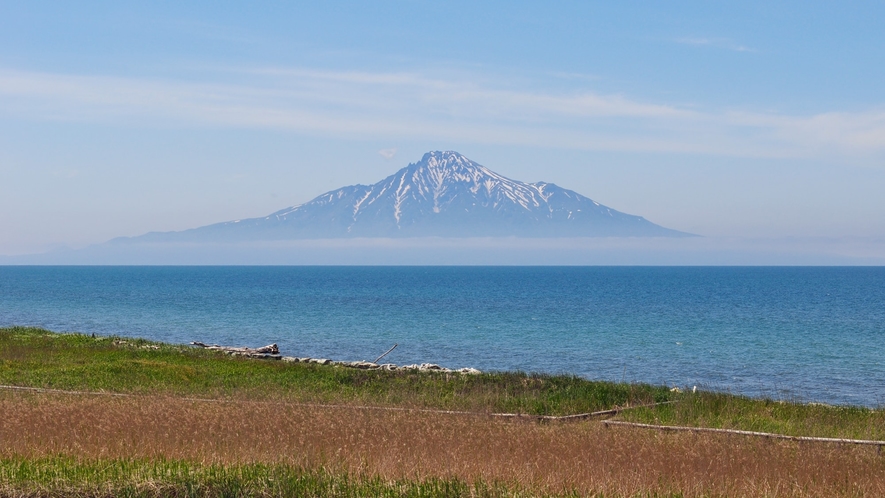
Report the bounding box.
[0,392,885,497]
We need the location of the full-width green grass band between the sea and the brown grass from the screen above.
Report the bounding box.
[0,327,885,440]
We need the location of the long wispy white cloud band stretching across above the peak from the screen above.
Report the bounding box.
[0,68,885,158]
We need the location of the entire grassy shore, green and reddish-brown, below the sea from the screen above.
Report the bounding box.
[0,327,885,497]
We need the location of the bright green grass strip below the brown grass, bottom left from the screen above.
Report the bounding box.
[0,457,522,498]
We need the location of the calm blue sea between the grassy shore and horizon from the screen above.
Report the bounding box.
[0,267,885,406]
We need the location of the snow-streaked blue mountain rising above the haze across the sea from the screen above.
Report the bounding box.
[111,151,693,244]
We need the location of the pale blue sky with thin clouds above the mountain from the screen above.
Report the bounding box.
[0,0,885,258]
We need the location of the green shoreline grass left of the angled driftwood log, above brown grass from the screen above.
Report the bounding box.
[0,327,671,415]
